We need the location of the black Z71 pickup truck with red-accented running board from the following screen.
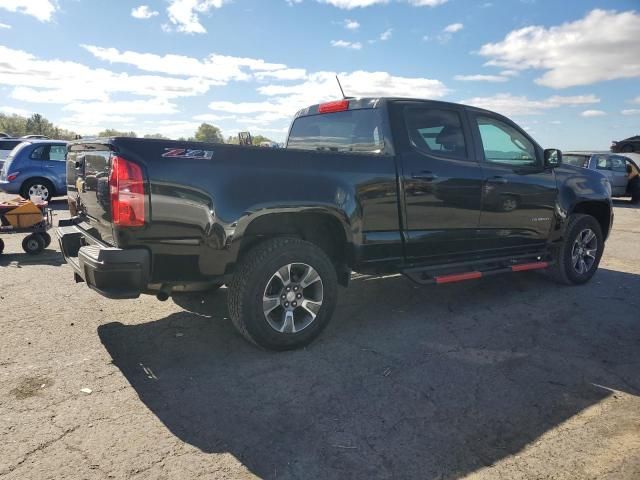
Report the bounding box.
[57,98,613,350]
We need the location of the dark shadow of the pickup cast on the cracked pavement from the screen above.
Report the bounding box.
[98,270,640,479]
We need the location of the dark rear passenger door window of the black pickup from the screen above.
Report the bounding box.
[405,107,467,159]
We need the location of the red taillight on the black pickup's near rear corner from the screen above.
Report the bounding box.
[109,156,145,227]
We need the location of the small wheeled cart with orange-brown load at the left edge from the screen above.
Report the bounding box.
[0,198,53,255]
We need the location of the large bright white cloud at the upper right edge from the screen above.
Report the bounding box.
[479,10,640,88]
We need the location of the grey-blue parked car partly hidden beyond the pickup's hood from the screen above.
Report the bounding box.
[563,152,640,203]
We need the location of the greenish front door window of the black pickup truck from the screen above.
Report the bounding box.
[477,117,539,167]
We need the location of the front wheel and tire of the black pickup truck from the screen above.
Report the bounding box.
[549,214,604,285]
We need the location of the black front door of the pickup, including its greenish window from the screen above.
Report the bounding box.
[470,113,558,254]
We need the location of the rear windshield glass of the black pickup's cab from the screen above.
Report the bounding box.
[287,109,384,154]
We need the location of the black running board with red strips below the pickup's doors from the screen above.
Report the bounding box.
[402,260,553,285]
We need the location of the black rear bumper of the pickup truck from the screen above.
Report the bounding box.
[56,221,151,299]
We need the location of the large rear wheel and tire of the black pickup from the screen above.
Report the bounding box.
[227,237,338,351]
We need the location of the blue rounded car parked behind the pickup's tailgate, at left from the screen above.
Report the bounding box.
[0,140,67,202]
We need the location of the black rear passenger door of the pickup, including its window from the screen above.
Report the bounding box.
[395,102,482,263]
